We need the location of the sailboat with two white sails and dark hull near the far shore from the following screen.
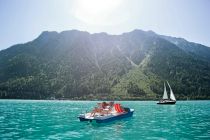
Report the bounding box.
[157,81,176,104]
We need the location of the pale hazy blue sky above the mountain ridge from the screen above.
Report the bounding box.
[0,0,210,50]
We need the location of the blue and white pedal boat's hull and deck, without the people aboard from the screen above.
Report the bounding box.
[78,102,134,123]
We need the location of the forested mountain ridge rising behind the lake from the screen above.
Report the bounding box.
[0,30,210,100]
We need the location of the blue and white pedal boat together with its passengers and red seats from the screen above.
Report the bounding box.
[78,102,134,123]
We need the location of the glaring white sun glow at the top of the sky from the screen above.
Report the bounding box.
[74,0,122,25]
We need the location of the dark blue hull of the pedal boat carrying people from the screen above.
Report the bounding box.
[78,109,134,123]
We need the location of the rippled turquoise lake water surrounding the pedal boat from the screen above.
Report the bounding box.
[0,100,210,140]
